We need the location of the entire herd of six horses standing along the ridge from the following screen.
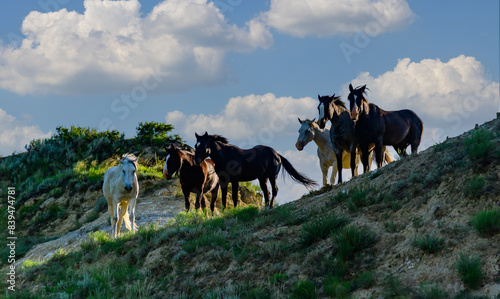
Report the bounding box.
[103,84,423,237]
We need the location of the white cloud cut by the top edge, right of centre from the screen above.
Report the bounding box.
[260,0,414,37]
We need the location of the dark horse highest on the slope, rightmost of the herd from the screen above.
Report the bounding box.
[347,84,424,172]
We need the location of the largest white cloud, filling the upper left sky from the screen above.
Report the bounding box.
[0,0,273,94]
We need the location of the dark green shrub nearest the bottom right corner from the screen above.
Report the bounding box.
[456,254,484,290]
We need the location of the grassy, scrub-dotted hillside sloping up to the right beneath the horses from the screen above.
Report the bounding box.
[3,118,500,298]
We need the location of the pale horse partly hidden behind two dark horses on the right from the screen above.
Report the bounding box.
[295,118,360,187]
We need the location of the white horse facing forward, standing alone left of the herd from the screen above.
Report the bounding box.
[102,154,139,238]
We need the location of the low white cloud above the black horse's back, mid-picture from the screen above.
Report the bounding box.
[165,93,317,145]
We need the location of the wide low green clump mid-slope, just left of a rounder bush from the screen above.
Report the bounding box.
[299,215,349,246]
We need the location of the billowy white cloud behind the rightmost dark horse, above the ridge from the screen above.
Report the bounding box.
[340,55,499,148]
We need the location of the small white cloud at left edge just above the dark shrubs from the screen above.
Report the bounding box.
[0,109,52,156]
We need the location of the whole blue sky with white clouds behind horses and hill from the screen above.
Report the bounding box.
[0,0,500,203]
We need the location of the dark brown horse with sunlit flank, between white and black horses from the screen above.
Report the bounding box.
[163,145,219,212]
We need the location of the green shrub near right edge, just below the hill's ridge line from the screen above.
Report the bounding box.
[464,129,496,163]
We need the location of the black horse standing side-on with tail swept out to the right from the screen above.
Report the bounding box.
[195,132,317,208]
